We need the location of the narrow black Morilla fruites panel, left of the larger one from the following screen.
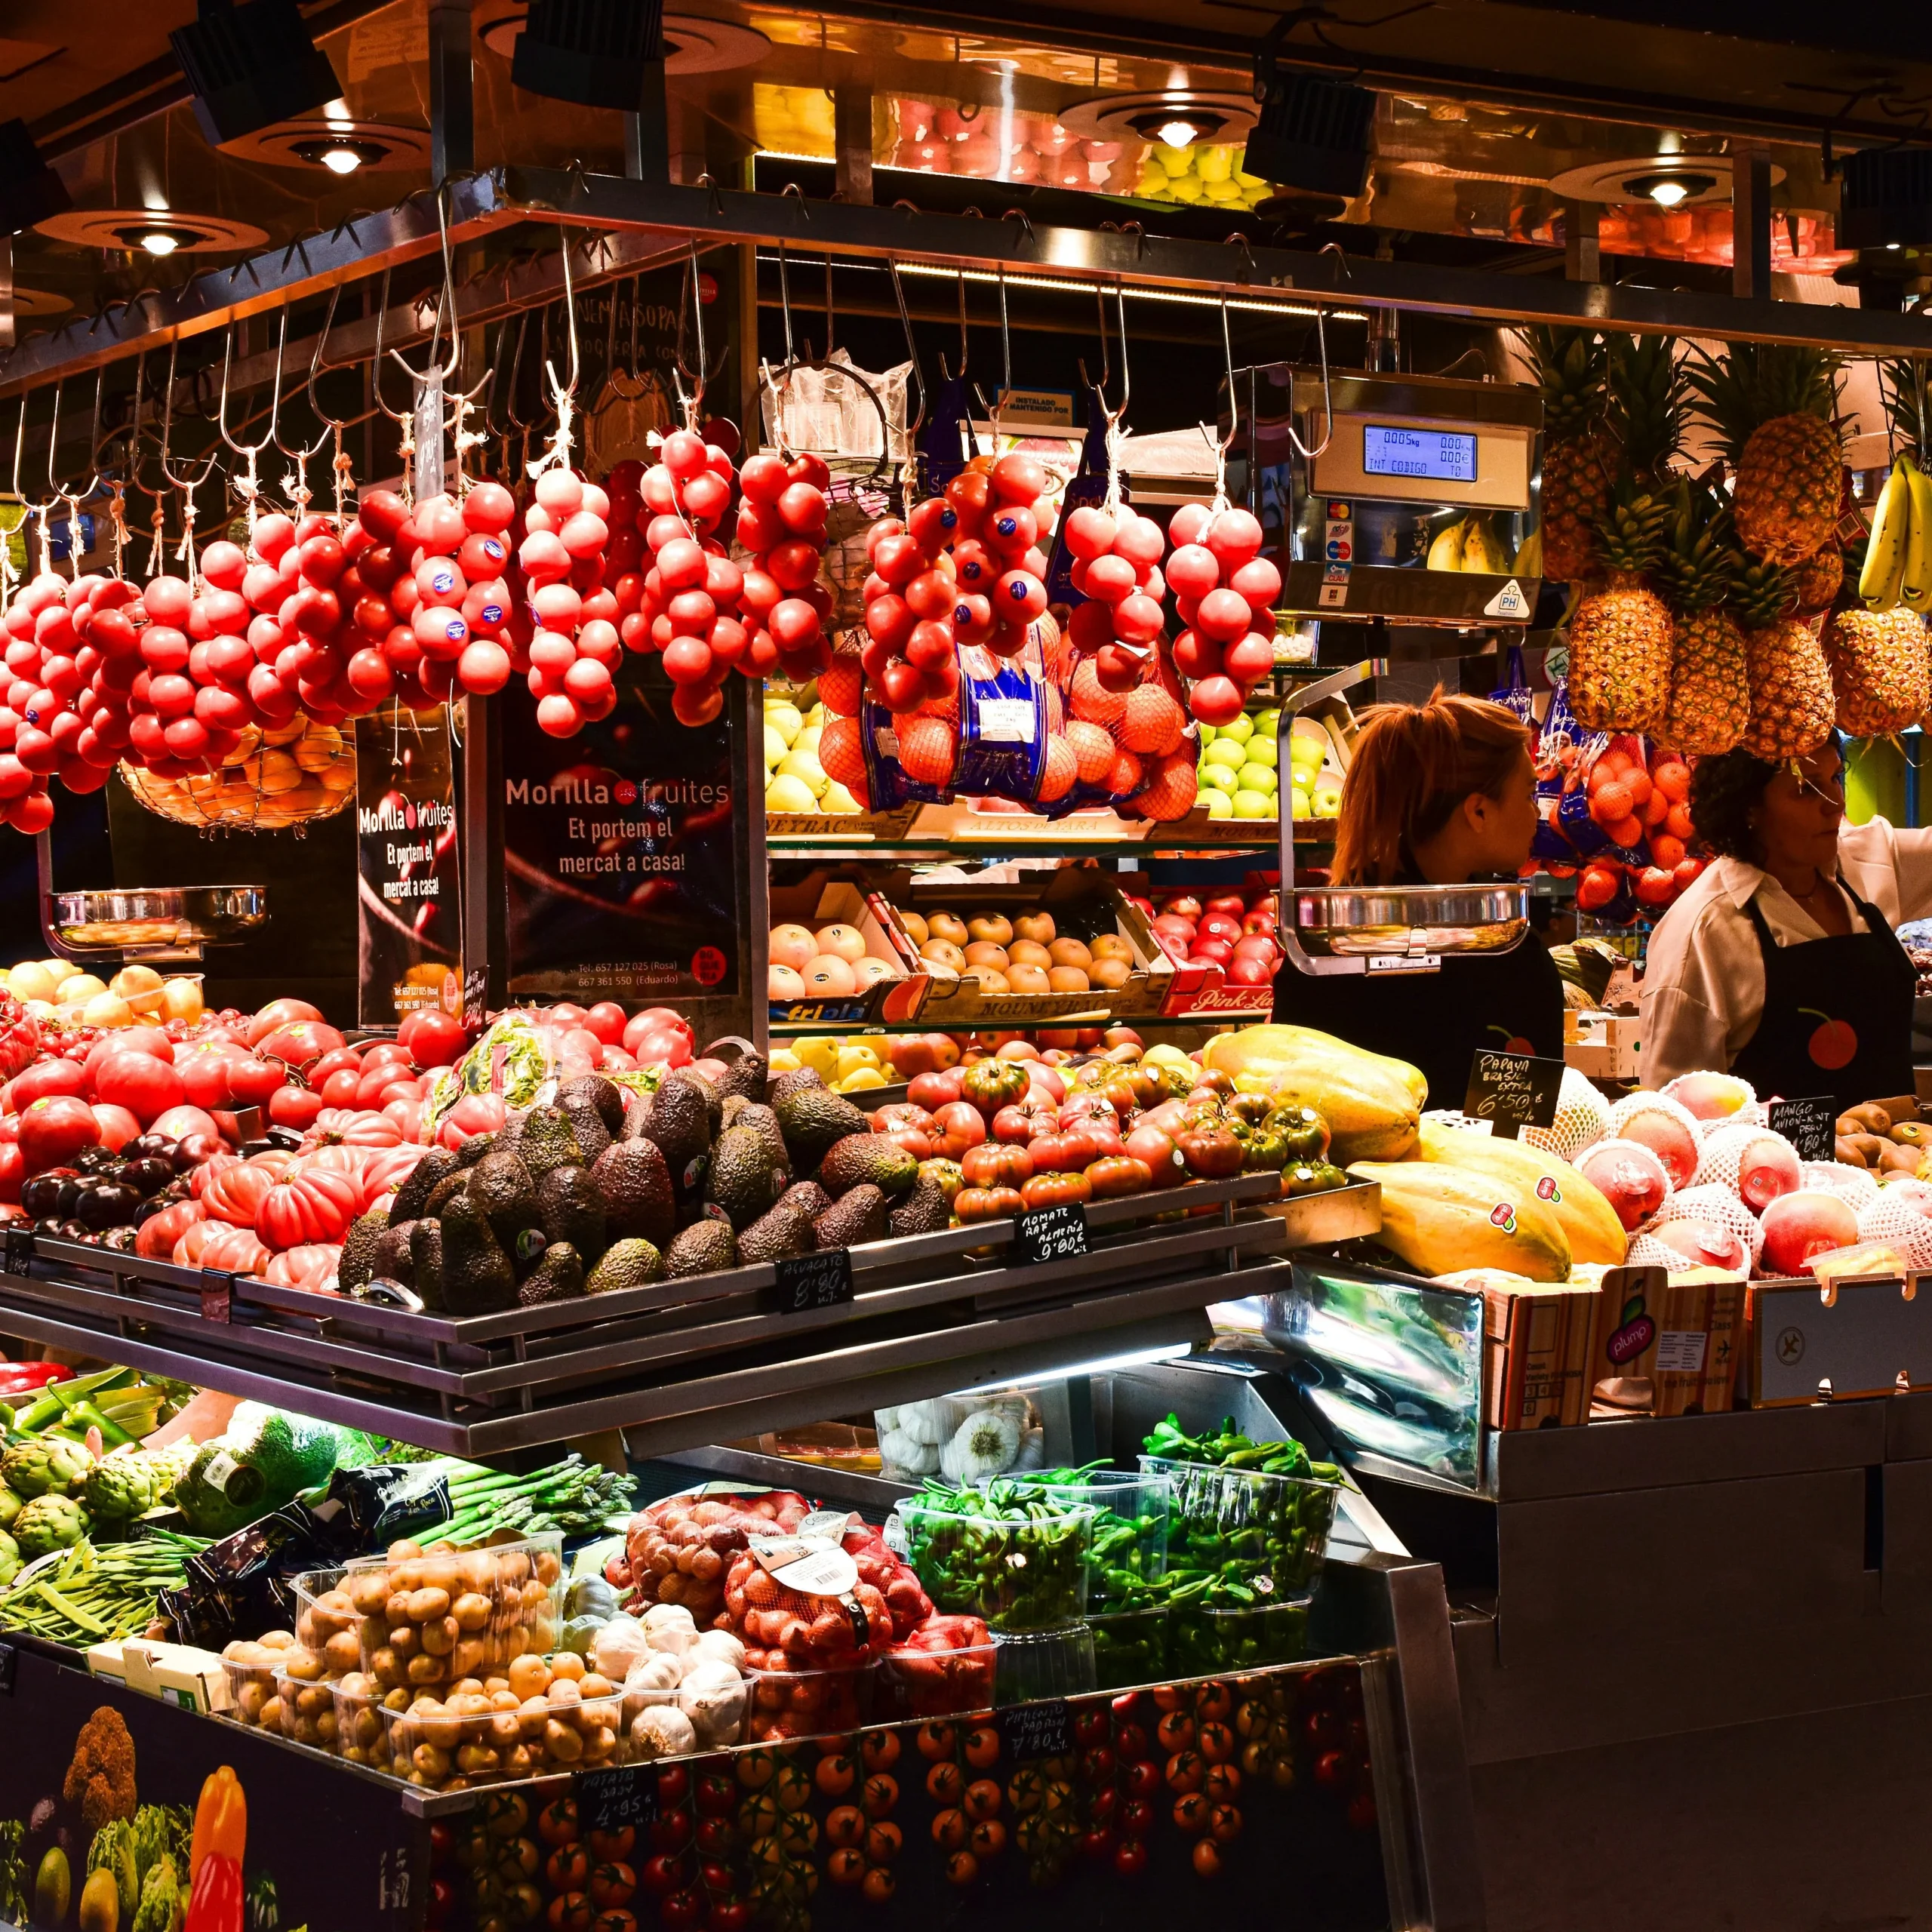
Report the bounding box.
[355,707,462,1026]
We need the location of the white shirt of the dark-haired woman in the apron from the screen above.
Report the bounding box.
[1638,819,1932,1088]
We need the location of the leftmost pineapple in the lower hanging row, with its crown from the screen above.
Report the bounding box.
[1569,477,1671,738]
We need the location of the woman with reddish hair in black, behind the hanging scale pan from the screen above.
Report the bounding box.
[1275,688,1563,1107]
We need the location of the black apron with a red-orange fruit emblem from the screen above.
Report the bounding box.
[1731,879,1918,1109]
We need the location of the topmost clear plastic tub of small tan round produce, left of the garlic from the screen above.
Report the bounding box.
[342,1531,565,1693]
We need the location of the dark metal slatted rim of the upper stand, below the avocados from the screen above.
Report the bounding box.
[0,1174,1380,1455]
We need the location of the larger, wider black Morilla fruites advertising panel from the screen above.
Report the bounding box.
[503,657,763,1018]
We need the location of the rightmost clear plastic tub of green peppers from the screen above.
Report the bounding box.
[1140,1455,1341,1607]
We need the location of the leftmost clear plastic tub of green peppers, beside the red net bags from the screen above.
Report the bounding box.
[898,1491,1094,1631]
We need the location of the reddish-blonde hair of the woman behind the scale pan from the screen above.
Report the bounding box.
[1329,684,1531,884]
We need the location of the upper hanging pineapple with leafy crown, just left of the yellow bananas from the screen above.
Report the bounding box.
[1690,342,1845,565]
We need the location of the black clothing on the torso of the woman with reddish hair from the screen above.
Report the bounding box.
[1275,933,1568,1107]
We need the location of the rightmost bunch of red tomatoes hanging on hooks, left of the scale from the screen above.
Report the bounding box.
[1167,503,1281,727]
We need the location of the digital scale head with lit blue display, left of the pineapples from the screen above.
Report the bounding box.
[1248,363,1543,630]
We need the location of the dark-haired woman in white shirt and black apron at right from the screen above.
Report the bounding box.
[1640,742,1932,1107]
